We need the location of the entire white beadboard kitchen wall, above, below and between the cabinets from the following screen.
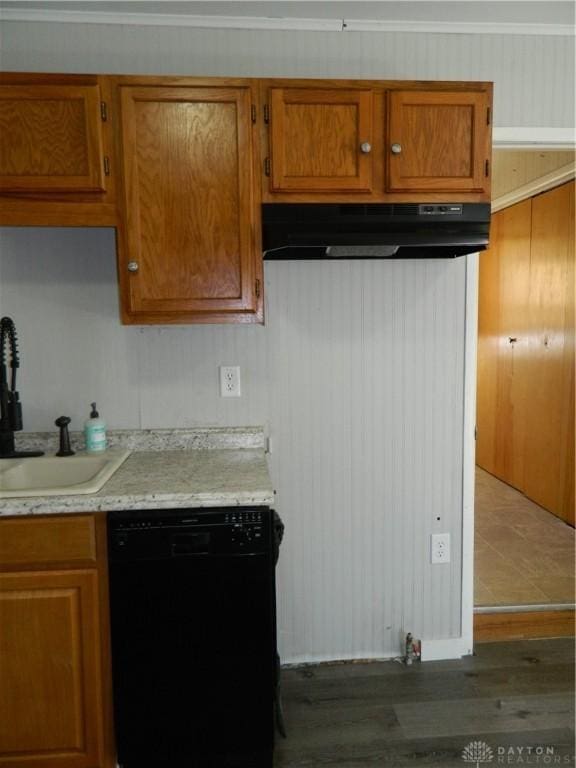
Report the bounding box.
[0,23,573,661]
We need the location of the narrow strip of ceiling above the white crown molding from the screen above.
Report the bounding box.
[0,0,575,27]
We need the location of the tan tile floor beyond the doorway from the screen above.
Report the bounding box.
[474,468,574,606]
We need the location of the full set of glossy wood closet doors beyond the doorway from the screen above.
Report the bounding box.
[477,182,574,525]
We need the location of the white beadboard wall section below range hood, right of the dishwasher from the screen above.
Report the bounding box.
[266,259,465,661]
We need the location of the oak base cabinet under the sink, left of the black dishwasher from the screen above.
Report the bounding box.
[0,515,115,768]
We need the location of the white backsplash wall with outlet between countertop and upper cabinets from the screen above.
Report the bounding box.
[0,227,267,431]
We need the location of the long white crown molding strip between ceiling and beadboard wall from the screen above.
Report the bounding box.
[0,8,575,37]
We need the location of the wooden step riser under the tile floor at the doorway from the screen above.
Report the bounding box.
[474,610,575,643]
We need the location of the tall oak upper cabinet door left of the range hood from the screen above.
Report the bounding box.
[120,86,261,322]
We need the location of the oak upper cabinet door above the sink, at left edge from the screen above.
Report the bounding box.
[0,85,106,192]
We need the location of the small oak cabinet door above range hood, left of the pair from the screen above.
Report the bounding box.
[270,88,373,192]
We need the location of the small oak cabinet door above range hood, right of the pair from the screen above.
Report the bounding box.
[387,91,491,195]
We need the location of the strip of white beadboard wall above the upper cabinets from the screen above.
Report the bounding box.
[2,21,574,128]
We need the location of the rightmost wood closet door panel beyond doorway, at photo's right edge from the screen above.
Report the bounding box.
[524,182,574,524]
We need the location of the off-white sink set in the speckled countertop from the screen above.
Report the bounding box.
[0,449,130,499]
